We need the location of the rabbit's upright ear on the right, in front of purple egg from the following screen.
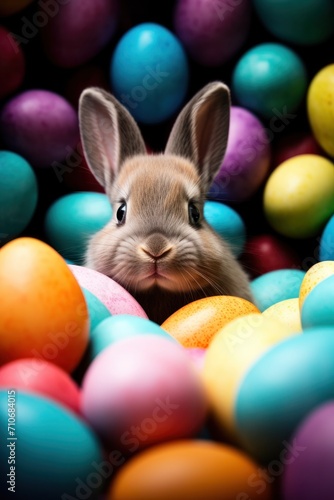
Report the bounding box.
[165,81,231,190]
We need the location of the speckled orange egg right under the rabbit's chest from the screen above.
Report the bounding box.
[161,295,260,348]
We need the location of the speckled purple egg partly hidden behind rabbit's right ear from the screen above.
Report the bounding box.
[210,106,271,202]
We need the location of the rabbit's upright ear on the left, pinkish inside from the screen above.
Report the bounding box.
[79,87,146,193]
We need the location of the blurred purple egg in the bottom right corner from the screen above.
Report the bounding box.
[282,401,334,500]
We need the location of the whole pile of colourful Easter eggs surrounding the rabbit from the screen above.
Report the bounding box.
[0,0,334,500]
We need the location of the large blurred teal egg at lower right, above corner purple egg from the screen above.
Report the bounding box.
[234,327,334,462]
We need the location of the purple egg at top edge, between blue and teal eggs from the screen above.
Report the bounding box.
[174,0,251,66]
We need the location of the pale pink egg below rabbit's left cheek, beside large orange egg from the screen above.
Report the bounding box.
[69,264,147,319]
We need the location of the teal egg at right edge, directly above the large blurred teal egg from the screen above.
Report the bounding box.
[301,276,334,330]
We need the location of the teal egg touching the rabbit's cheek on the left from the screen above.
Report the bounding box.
[44,192,112,265]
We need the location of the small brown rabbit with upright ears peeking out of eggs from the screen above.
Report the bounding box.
[79,81,252,324]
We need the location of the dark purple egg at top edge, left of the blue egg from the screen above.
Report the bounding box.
[42,0,119,68]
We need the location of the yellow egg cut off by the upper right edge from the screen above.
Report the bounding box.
[307,64,334,157]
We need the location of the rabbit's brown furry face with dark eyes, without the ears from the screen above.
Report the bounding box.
[87,155,219,292]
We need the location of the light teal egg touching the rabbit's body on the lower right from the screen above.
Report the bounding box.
[250,269,305,311]
